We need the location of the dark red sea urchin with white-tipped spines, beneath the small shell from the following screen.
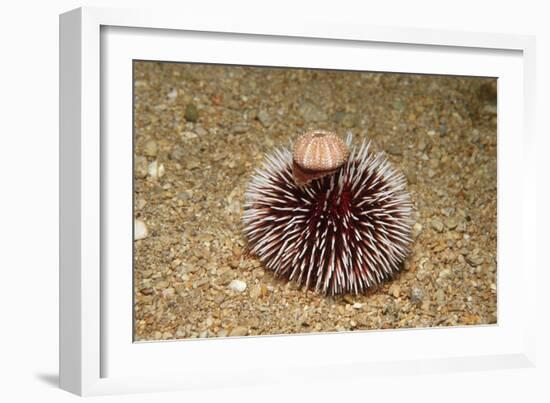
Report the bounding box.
[243,136,412,295]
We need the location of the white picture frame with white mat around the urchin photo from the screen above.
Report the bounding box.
[60,8,536,395]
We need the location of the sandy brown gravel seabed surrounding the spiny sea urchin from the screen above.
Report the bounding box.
[134,61,497,341]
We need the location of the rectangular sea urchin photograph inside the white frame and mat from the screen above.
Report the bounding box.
[134,60,498,342]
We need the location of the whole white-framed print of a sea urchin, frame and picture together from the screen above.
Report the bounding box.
[60,8,535,395]
